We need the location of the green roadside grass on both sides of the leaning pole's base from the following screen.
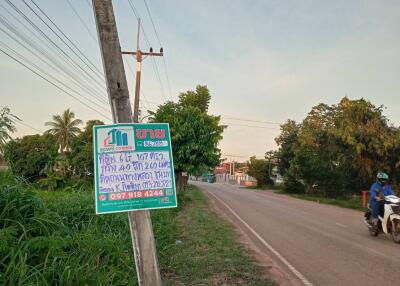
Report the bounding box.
[0,178,272,285]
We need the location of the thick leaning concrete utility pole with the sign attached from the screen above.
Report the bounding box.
[93,0,161,286]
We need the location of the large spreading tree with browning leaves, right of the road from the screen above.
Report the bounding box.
[276,97,400,197]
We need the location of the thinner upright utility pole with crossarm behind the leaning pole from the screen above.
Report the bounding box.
[122,18,163,122]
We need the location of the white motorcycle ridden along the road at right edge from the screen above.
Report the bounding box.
[364,195,400,243]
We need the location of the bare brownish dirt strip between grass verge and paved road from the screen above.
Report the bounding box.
[204,191,303,286]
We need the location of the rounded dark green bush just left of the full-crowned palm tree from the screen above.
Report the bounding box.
[4,134,58,182]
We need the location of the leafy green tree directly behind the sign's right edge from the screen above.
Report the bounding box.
[150,86,225,177]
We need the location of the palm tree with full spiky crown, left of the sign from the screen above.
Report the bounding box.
[46,108,82,154]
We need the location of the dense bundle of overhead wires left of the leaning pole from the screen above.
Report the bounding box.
[0,0,111,120]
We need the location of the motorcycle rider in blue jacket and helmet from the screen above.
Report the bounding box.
[369,172,393,224]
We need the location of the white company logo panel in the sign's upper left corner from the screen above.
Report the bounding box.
[99,127,134,153]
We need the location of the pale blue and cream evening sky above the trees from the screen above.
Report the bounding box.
[0,0,400,161]
